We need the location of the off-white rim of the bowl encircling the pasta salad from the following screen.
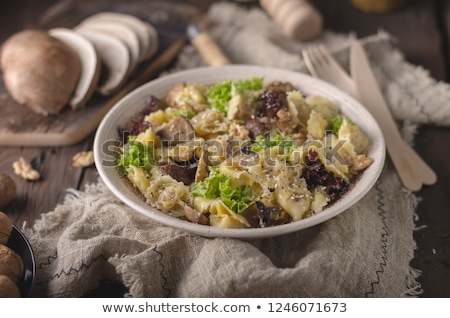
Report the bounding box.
[93,64,386,239]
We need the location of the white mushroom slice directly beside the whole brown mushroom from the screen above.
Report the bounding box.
[48,28,102,109]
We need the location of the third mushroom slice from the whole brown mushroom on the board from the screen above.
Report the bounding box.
[74,20,141,72]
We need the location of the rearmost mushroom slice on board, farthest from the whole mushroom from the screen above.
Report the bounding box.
[80,12,158,62]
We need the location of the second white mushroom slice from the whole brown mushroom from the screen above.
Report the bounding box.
[77,30,130,96]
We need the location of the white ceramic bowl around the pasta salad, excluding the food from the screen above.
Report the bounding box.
[94,65,385,239]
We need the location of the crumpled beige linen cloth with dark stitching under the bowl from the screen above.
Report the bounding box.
[25,3,450,297]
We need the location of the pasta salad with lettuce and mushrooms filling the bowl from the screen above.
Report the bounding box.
[117,78,373,228]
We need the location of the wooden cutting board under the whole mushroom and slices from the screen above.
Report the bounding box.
[0,0,202,146]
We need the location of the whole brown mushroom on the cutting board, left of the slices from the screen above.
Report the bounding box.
[0,30,81,115]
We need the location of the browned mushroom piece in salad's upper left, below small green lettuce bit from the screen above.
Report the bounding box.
[156,115,195,146]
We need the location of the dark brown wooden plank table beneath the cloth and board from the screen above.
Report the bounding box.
[0,0,450,297]
